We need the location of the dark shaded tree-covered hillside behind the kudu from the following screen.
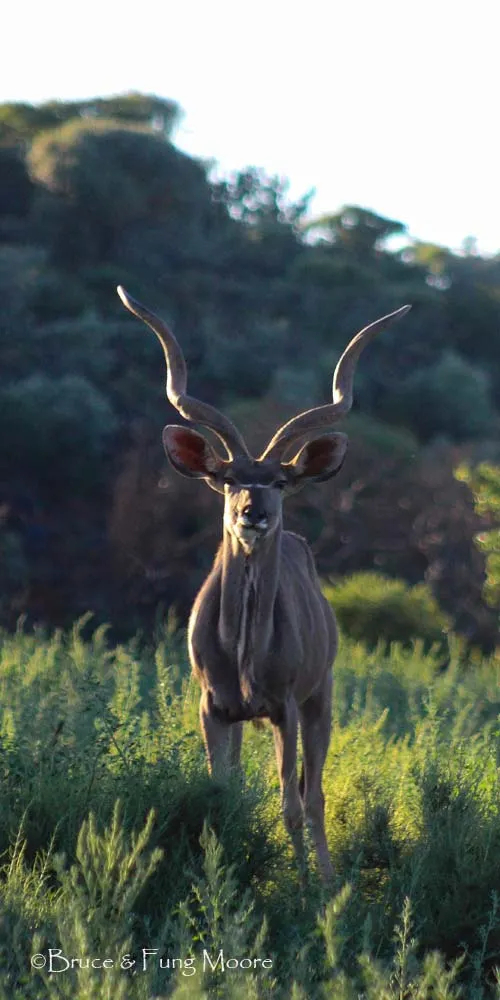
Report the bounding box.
[0,94,500,649]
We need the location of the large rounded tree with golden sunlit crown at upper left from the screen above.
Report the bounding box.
[29,119,210,268]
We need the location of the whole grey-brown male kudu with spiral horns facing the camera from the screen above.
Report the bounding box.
[118,287,410,879]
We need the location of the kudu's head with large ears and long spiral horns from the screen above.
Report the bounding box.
[118,285,411,554]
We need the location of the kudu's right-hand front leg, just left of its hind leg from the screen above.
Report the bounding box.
[273,699,305,880]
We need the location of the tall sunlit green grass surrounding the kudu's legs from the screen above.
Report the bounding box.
[0,622,500,1000]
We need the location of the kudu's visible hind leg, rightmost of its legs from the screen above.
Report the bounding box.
[300,672,333,882]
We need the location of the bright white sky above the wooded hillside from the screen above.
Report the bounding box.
[4,0,500,252]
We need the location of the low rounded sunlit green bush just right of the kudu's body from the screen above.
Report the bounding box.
[323,572,450,646]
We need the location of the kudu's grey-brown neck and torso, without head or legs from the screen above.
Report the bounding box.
[189,526,336,721]
